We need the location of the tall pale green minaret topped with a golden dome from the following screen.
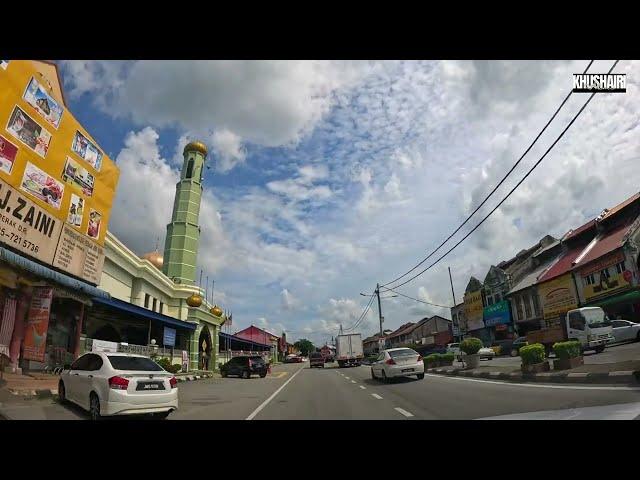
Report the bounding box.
[162,142,207,285]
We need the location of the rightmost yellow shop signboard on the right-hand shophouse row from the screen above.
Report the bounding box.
[579,250,633,302]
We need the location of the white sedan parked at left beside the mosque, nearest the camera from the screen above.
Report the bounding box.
[58,352,178,420]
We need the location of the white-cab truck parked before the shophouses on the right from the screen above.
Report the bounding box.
[527,307,613,356]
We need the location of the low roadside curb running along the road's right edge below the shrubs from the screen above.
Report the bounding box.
[426,368,640,384]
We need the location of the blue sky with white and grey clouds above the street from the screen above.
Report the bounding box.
[59,60,640,345]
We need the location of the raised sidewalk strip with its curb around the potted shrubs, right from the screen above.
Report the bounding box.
[426,360,640,384]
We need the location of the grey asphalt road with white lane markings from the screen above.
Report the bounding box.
[0,364,640,420]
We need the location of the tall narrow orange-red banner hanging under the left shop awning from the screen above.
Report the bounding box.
[22,287,53,362]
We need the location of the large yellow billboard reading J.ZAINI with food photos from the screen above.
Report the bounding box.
[0,60,120,284]
